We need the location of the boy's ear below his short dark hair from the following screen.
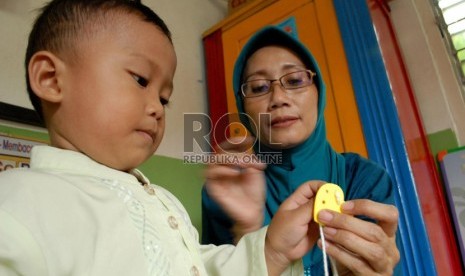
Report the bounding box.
[28,51,64,103]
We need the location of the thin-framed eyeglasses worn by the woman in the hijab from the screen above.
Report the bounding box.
[241,70,316,98]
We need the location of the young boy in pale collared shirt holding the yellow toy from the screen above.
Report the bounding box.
[0,0,315,276]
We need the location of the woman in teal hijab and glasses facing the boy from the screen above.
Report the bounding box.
[202,26,399,275]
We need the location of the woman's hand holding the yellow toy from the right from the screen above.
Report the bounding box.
[318,199,400,275]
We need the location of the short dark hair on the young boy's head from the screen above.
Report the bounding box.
[25,0,172,121]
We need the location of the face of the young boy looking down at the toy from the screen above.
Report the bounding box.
[49,13,176,171]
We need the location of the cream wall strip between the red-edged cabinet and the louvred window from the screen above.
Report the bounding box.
[389,0,465,145]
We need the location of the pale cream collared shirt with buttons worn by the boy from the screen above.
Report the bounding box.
[0,146,301,276]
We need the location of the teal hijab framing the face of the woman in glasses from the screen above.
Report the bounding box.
[233,26,345,224]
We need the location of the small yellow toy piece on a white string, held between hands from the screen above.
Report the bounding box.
[313,183,344,225]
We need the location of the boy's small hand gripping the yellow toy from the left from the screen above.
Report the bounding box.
[265,181,324,275]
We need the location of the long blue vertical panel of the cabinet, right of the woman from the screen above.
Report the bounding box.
[334,0,436,276]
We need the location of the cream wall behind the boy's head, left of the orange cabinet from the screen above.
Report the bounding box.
[0,0,227,158]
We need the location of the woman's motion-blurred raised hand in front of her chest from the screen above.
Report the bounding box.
[205,137,266,242]
